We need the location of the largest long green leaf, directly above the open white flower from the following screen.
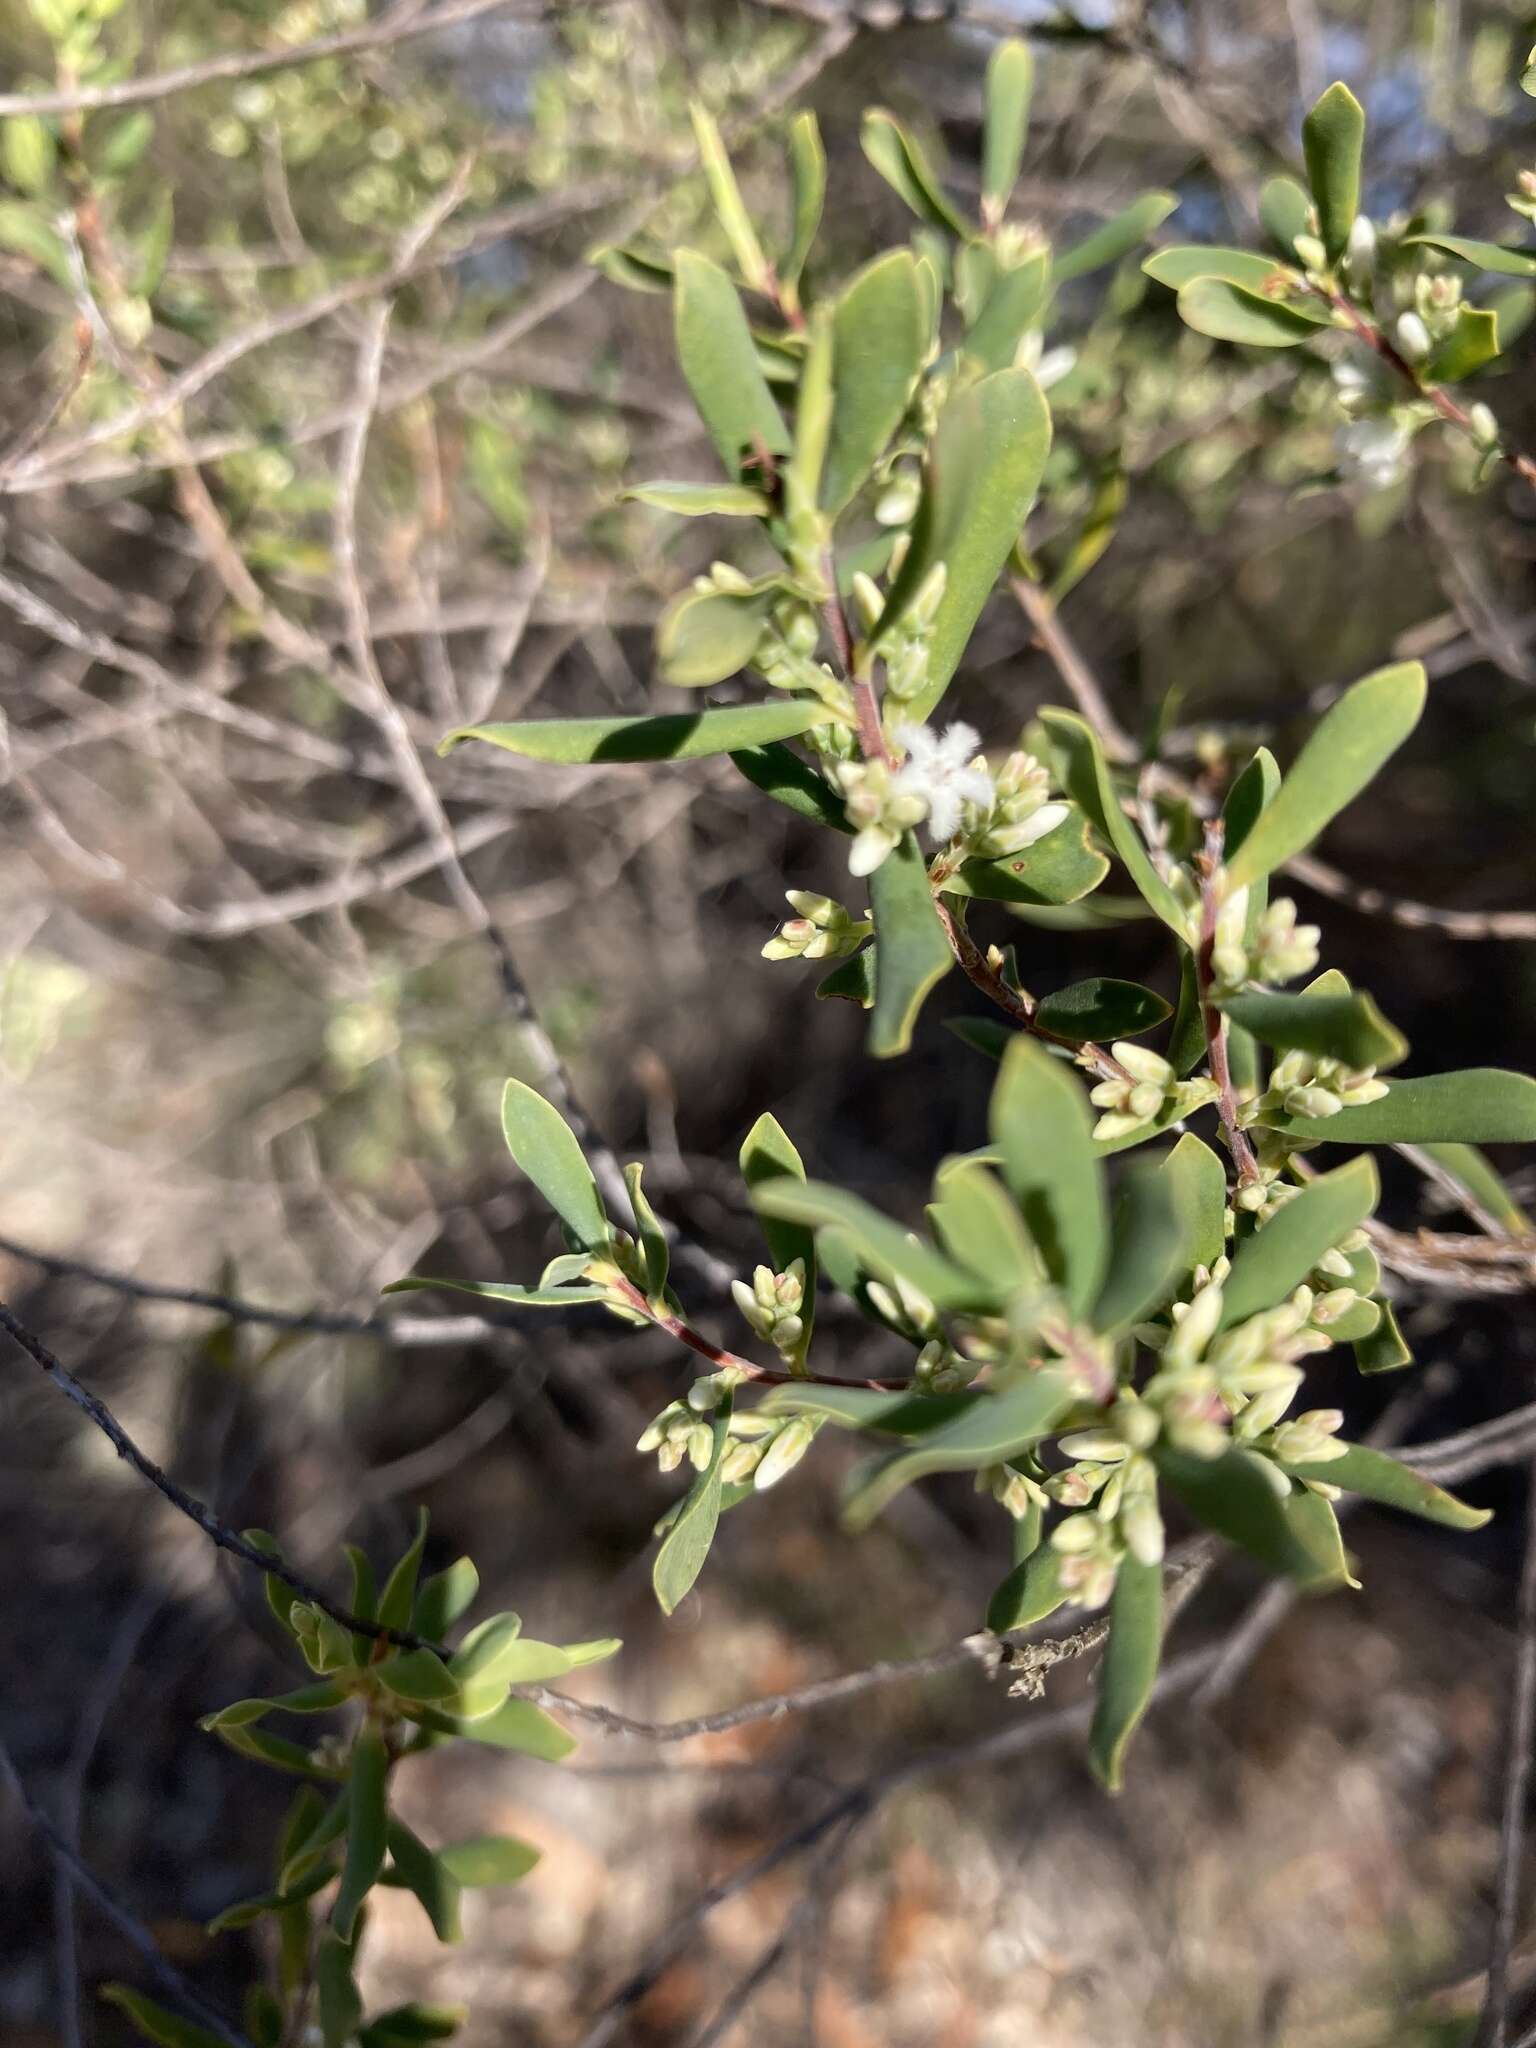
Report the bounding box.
[884,369,1051,721]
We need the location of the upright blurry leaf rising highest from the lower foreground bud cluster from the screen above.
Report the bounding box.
[991,1036,1108,1315]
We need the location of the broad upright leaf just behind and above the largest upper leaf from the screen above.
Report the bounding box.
[821,250,928,516]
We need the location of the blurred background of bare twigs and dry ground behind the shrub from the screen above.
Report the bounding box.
[0,0,1536,2048]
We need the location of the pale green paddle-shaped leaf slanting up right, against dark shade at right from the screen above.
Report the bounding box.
[1229,662,1427,887]
